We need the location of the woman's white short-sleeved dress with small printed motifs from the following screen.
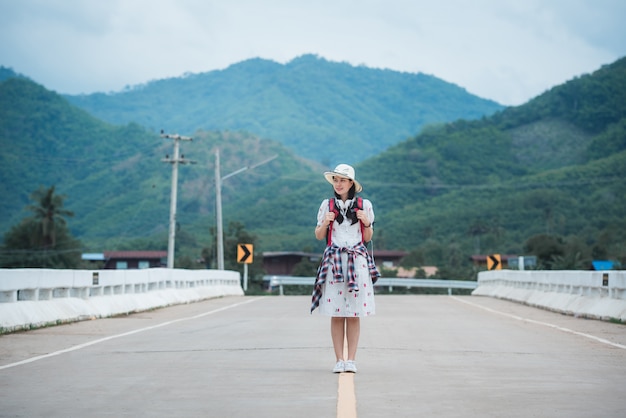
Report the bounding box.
[317,199,376,317]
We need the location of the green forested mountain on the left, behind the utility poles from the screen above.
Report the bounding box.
[0,78,321,251]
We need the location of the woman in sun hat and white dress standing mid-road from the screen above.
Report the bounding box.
[311,164,380,373]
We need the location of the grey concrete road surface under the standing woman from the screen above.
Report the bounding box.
[0,295,626,418]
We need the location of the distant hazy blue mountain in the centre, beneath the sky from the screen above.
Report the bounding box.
[65,55,503,166]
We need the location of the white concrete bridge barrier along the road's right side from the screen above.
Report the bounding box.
[472,270,626,321]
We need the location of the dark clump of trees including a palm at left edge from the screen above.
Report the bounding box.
[0,186,81,268]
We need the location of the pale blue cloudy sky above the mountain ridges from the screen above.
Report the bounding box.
[0,0,626,106]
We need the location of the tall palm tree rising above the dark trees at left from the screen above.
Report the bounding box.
[27,186,74,249]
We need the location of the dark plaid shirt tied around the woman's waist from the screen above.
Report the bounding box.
[311,243,380,313]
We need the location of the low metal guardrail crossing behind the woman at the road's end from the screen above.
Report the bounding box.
[263,276,478,296]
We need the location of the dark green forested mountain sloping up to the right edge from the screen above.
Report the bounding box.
[233,59,626,264]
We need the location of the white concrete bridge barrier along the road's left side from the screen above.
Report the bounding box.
[0,268,244,333]
